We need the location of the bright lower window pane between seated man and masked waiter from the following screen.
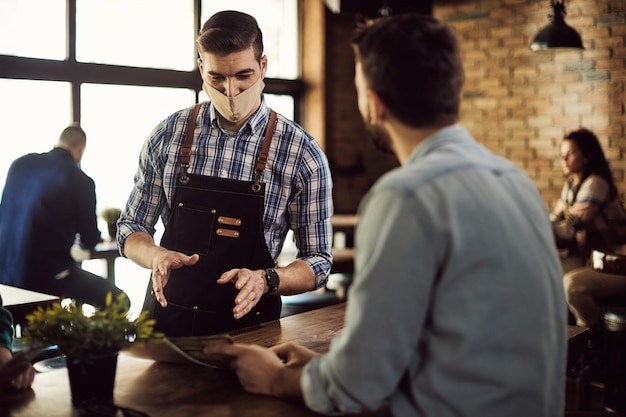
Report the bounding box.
[81,84,195,211]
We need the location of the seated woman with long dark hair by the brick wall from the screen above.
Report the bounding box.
[551,129,626,330]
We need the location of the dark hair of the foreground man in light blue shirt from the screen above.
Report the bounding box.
[352,13,464,127]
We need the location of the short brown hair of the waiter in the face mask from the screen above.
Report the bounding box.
[196,10,263,62]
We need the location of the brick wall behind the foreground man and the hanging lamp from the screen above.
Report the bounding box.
[326,0,626,212]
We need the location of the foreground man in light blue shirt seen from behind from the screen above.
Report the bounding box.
[205,14,567,417]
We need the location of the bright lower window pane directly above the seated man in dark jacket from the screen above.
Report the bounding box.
[0,79,72,200]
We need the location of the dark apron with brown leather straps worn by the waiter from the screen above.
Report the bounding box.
[144,104,281,337]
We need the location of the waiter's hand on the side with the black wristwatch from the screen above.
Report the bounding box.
[217,268,267,319]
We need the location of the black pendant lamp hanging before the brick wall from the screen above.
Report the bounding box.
[530,0,585,52]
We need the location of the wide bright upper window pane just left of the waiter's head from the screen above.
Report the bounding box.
[76,0,196,71]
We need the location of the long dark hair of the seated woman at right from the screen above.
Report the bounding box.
[563,128,617,198]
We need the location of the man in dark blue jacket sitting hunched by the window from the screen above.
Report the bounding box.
[0,124,123,308]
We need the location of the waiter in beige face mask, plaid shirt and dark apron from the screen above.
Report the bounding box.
[117,11,333,337]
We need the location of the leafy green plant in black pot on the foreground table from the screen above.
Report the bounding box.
[24,293,163,405]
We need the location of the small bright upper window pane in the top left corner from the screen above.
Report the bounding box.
[0,0,67,59]
